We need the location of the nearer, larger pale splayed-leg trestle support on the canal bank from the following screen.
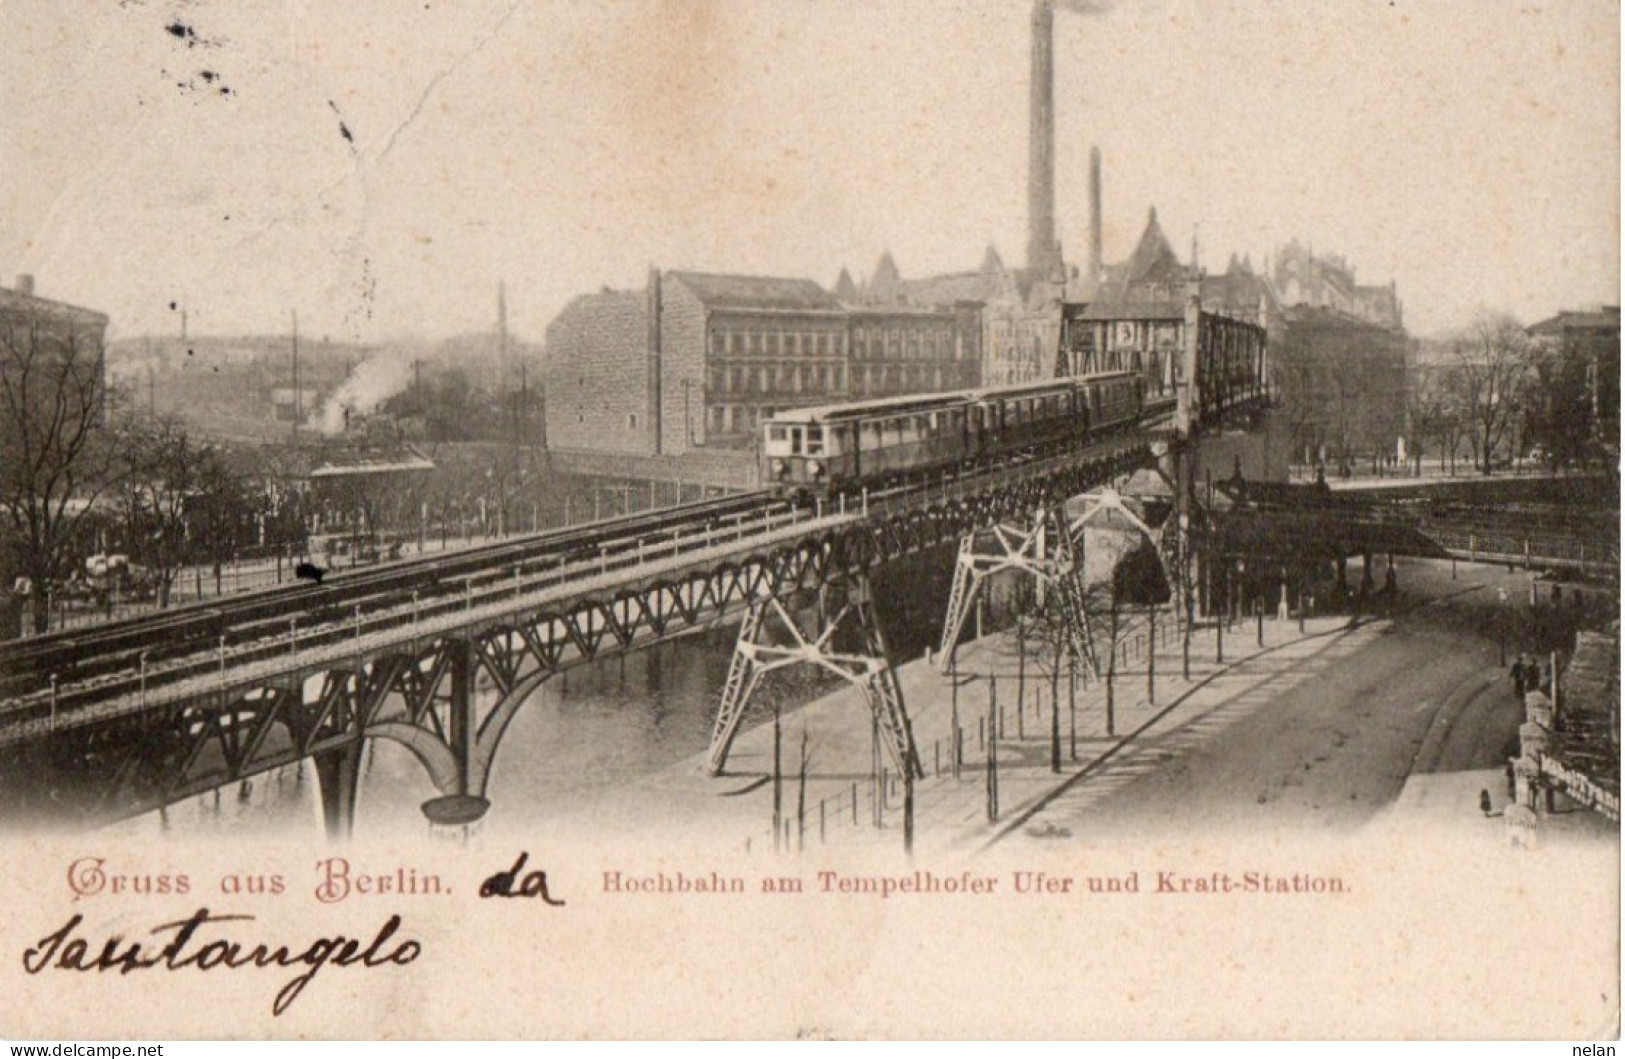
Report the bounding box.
[707,575,925,848]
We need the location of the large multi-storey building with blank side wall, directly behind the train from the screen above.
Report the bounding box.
[546,271,982,455]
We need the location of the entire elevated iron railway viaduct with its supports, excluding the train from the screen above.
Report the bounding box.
[0,302,1319,835]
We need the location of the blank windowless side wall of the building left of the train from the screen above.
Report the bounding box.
[546,291,655,456]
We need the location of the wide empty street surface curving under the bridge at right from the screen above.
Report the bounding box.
[1024,562,1528,838]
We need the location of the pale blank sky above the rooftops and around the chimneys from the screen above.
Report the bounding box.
[0,0,1620,341]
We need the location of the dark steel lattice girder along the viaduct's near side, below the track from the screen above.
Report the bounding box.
[31,443,1149,815]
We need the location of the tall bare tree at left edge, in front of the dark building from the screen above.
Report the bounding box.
[0,309,119,633]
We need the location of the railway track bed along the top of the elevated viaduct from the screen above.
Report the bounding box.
[0,414,1157,744]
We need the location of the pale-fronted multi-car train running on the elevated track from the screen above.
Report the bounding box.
[762,372,1144,497]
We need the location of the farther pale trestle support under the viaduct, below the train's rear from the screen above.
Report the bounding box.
[936,506,1092,677]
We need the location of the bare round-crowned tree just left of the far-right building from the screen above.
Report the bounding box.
[1451,313,1531,474]
